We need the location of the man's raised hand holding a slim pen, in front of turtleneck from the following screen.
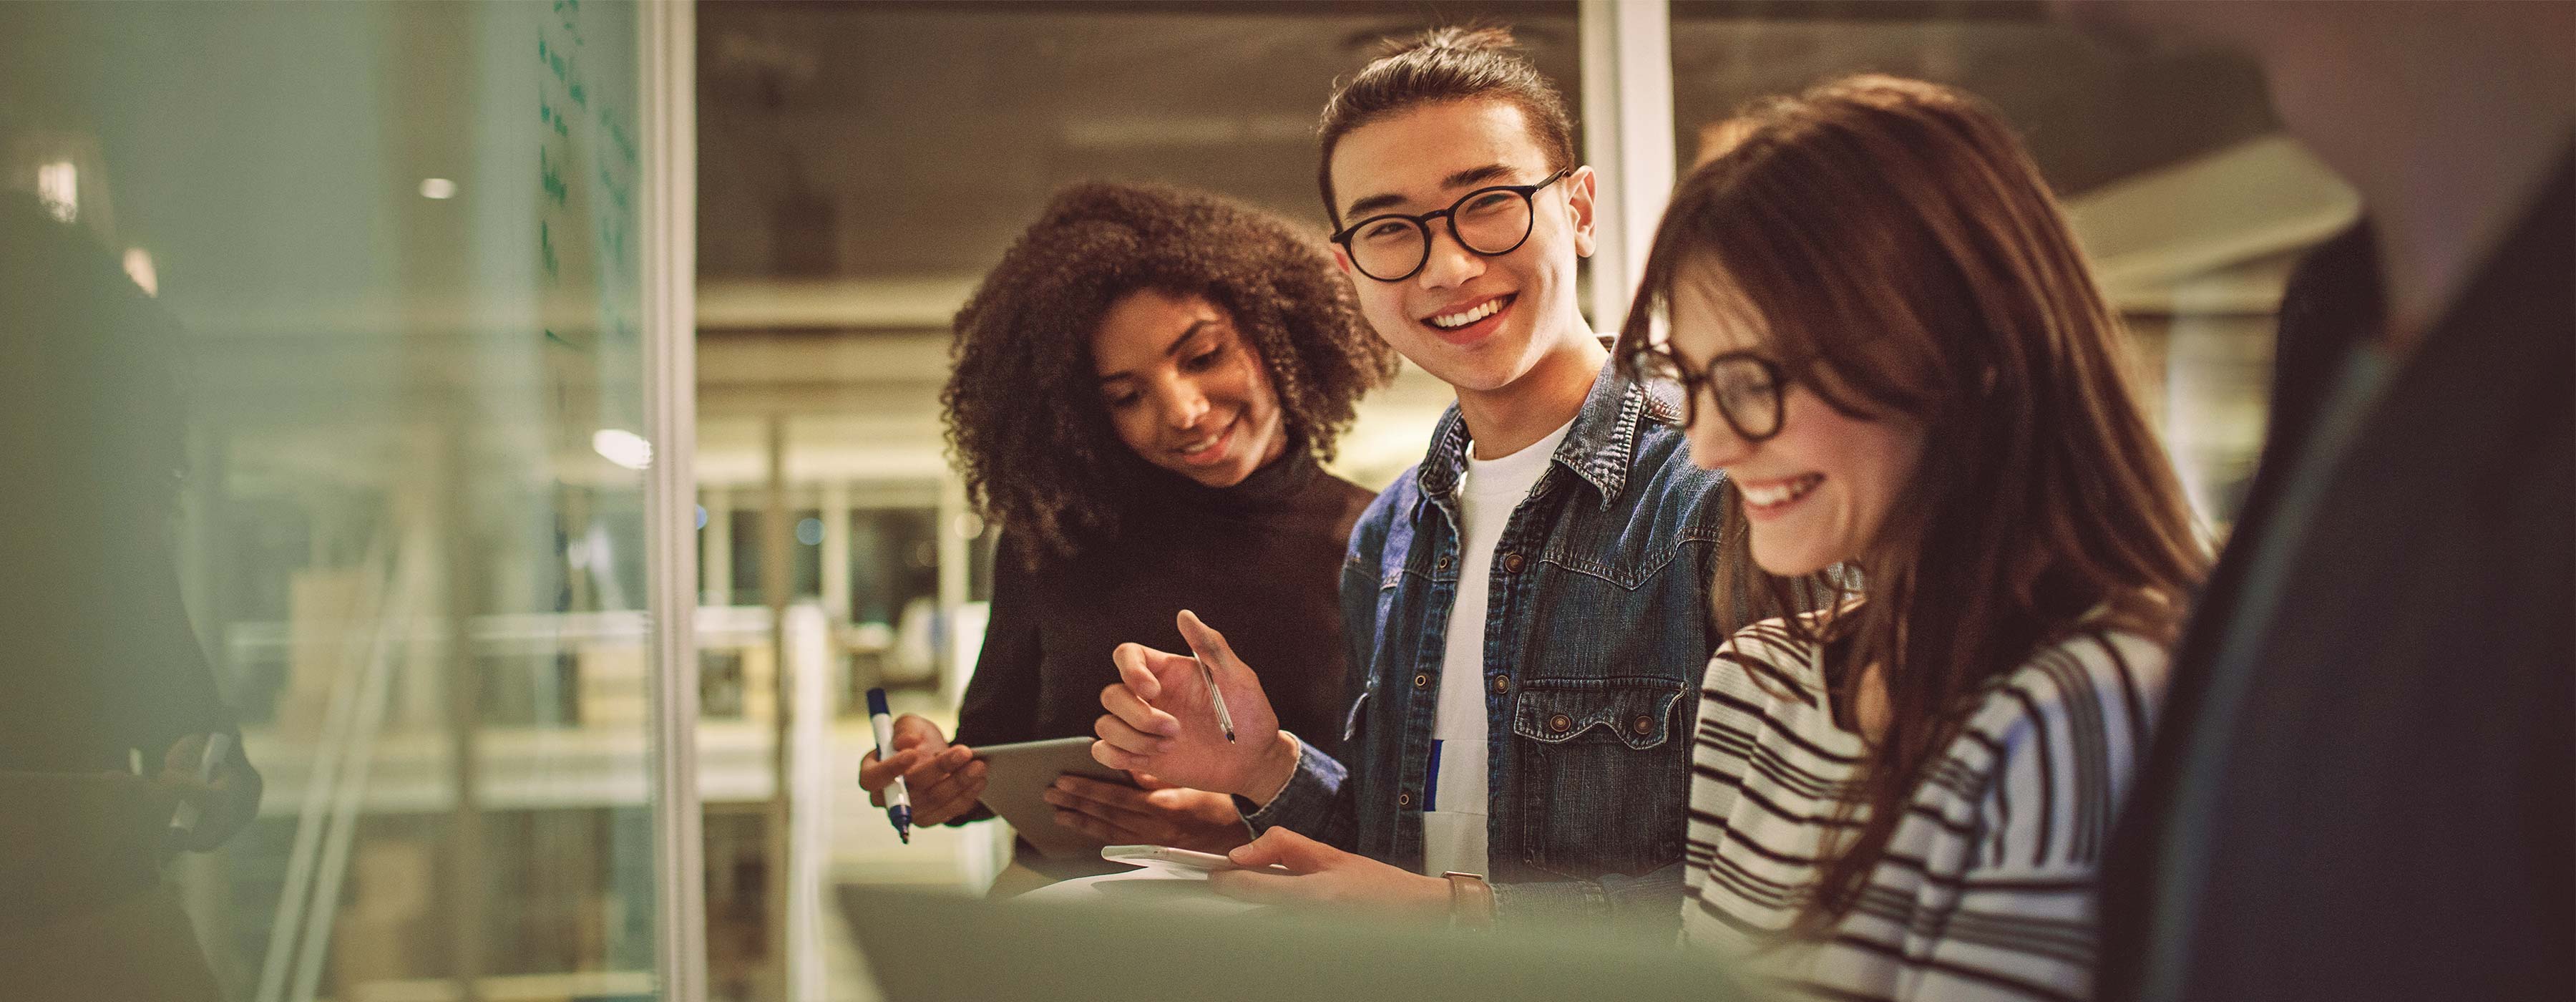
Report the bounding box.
[1092,611,1296,801]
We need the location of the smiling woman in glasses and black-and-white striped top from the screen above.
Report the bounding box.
[1620,77,2205,999]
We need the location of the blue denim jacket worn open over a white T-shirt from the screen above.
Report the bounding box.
[1241,353,1734,928]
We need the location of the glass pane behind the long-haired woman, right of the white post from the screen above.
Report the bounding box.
[1672,3,2357,533]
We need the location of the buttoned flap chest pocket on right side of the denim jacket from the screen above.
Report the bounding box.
[1512,678,1690,881]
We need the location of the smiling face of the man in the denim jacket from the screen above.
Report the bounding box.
[1332,100,1592,391]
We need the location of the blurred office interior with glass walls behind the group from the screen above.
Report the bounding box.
[0,0,2354,1002]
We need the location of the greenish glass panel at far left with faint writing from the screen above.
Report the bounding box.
[0,0,660,1002]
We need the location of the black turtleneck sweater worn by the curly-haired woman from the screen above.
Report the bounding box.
[956,451,1373,752]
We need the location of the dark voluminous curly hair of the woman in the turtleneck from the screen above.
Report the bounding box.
[940,183,1396,564]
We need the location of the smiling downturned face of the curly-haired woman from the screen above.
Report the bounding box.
[1092,288,1288,487]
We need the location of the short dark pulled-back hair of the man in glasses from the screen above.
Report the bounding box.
[1317,26,1579,227]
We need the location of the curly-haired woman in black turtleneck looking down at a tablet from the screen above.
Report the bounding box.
[860,183,1396,852]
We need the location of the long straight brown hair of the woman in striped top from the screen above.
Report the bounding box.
[1620,74,2207,933]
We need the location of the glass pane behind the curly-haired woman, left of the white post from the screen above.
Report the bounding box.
[696,3,1581,997]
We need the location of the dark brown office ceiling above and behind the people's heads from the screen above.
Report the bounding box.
[698,3,2272,283]
